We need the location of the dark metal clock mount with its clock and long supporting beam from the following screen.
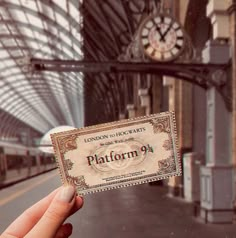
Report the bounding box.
[30,0,232,111]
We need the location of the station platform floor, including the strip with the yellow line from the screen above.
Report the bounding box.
[0,170,236,238]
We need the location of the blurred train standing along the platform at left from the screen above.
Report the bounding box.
[0,141,57,188]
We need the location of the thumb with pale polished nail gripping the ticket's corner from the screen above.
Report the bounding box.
[25,185,75,238]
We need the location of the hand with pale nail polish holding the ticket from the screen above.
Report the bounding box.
[0,185,83,238]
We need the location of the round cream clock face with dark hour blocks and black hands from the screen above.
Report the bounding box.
[140,15,185,62]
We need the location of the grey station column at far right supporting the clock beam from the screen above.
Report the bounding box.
[200,0,235,223]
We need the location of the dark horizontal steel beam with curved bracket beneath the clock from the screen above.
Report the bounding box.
[30,58,232,110]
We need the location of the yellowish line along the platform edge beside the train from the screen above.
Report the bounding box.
[0,172,57,207]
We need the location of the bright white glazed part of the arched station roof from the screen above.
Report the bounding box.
[0,0,83,137]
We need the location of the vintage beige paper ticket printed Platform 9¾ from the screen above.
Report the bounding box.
[51,112,181,195]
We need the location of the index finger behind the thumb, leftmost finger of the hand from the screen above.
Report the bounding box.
[2,189,58,237]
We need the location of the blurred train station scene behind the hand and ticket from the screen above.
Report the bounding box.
[0,0,236,238]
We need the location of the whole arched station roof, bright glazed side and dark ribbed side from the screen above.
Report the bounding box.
[0,0,203,137]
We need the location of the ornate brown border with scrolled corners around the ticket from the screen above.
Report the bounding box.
[51,111,182,195]
